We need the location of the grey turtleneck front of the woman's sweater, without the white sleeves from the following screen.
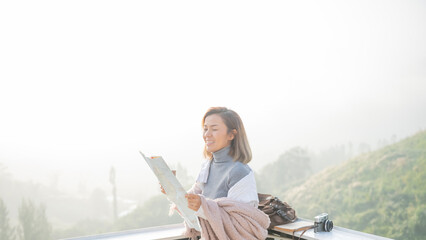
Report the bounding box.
[202,146,251,199]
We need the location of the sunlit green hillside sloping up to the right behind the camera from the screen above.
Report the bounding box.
[282,131,426,239]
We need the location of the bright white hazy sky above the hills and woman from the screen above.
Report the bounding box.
[0,0,426,199]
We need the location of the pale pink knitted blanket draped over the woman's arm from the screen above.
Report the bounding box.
[185,195,269,240]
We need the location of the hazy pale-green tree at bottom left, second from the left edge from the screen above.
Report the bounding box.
[18,199,52,240]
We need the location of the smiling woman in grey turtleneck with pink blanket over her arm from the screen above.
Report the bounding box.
[181,107,269,239]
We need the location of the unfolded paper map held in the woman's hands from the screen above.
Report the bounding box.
[139,151,201,231]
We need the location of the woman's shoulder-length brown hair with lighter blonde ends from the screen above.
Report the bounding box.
[201,107,252,164]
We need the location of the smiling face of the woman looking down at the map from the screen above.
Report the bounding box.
[203,114,235,152]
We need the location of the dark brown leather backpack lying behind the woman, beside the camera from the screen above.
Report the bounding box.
[257,193,297,229]
